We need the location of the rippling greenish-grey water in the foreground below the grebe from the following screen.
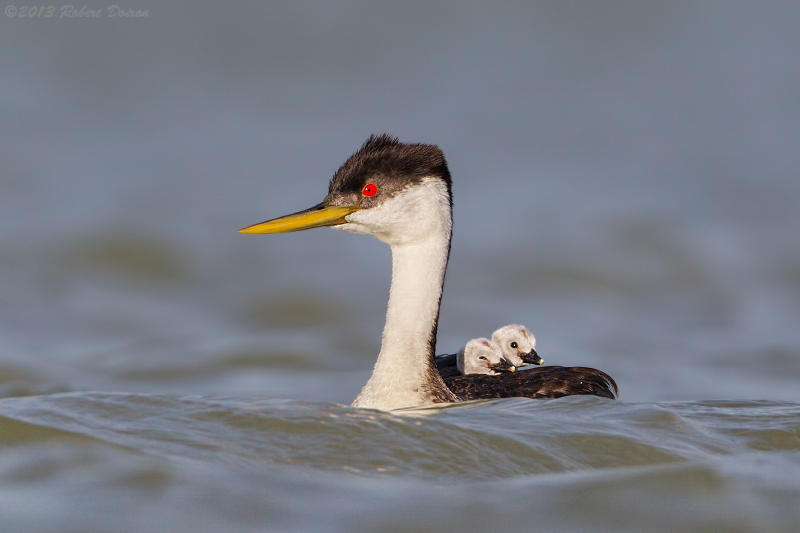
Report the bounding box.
[0,392,800,531]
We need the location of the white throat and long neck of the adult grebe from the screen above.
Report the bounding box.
[337,178,455,409]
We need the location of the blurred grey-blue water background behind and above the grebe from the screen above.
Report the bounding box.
[0,1,800,403]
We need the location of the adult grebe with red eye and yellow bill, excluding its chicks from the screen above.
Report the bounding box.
[240,134,616,409]
